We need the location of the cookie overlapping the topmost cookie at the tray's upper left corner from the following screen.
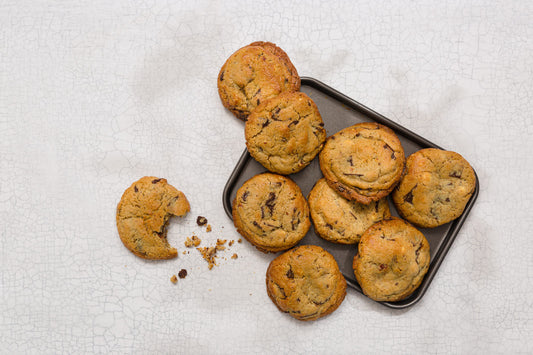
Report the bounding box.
[244,92,326,174]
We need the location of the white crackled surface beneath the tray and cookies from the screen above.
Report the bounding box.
[0,0,533,354]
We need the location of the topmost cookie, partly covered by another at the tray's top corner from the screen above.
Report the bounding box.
[218,42,300,121]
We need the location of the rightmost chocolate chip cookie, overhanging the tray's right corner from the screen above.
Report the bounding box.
[392,148,476,227]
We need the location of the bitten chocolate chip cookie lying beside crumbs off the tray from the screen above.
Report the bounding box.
[116,176,190,259]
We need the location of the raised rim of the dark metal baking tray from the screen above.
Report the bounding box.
[222,76,479,309]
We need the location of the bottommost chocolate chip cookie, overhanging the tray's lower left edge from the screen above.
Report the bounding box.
[266,245,346,321]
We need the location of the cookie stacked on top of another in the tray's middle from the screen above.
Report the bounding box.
[319,122,405,204]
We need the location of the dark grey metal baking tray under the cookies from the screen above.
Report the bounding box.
[223,77,479,309]
